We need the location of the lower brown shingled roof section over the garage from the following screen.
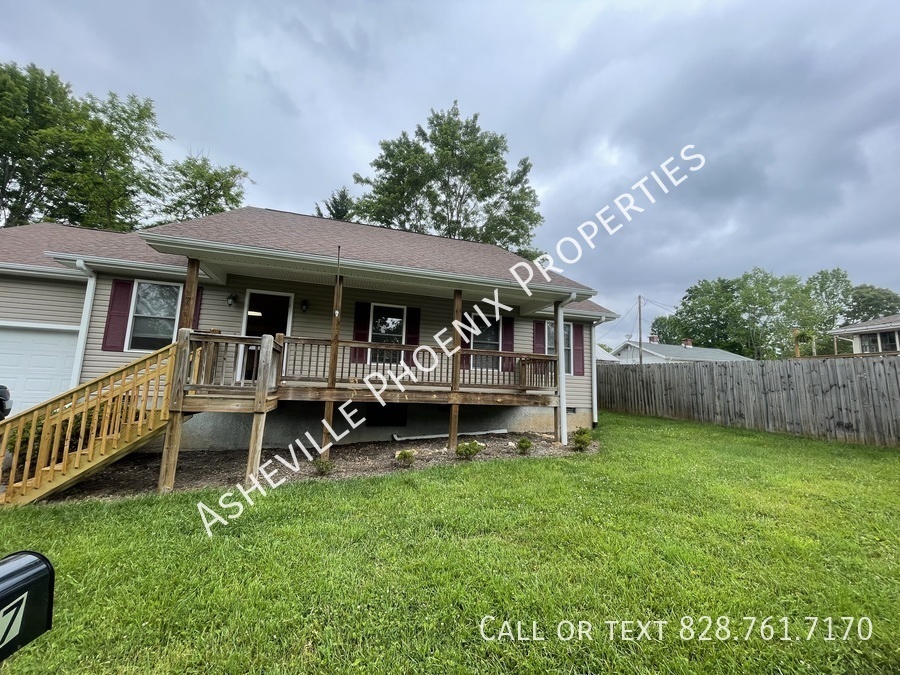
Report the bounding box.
[0,223,187,268]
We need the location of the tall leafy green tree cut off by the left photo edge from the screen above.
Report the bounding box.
[0,63,86,227]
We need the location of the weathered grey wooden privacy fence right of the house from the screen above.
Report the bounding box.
[597,356,900,446]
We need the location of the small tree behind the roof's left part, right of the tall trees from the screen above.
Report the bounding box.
[159,155,252,222]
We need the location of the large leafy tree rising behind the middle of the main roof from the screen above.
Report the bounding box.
[353,101,543,250]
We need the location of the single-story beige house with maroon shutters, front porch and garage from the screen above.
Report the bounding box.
[0,207,616,500]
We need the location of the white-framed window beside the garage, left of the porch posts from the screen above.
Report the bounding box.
[128,281,181,351]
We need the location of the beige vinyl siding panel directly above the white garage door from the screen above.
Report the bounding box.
[0,276,87,326]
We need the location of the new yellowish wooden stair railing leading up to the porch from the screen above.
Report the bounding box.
[0,345,175,503]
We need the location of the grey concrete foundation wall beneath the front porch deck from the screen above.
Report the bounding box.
[147,401,591,451]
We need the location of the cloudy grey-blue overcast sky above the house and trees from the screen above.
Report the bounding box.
[0,0,900,345]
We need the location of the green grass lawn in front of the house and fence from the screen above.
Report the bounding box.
[0,414,900,675]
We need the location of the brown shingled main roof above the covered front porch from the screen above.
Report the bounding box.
[144,206,589,290]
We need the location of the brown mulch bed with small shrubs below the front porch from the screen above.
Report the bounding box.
[47,433,597,501]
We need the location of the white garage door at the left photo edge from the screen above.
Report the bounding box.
[0,326,78,414]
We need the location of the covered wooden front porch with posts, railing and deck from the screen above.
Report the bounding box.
[159,246,584,492]
